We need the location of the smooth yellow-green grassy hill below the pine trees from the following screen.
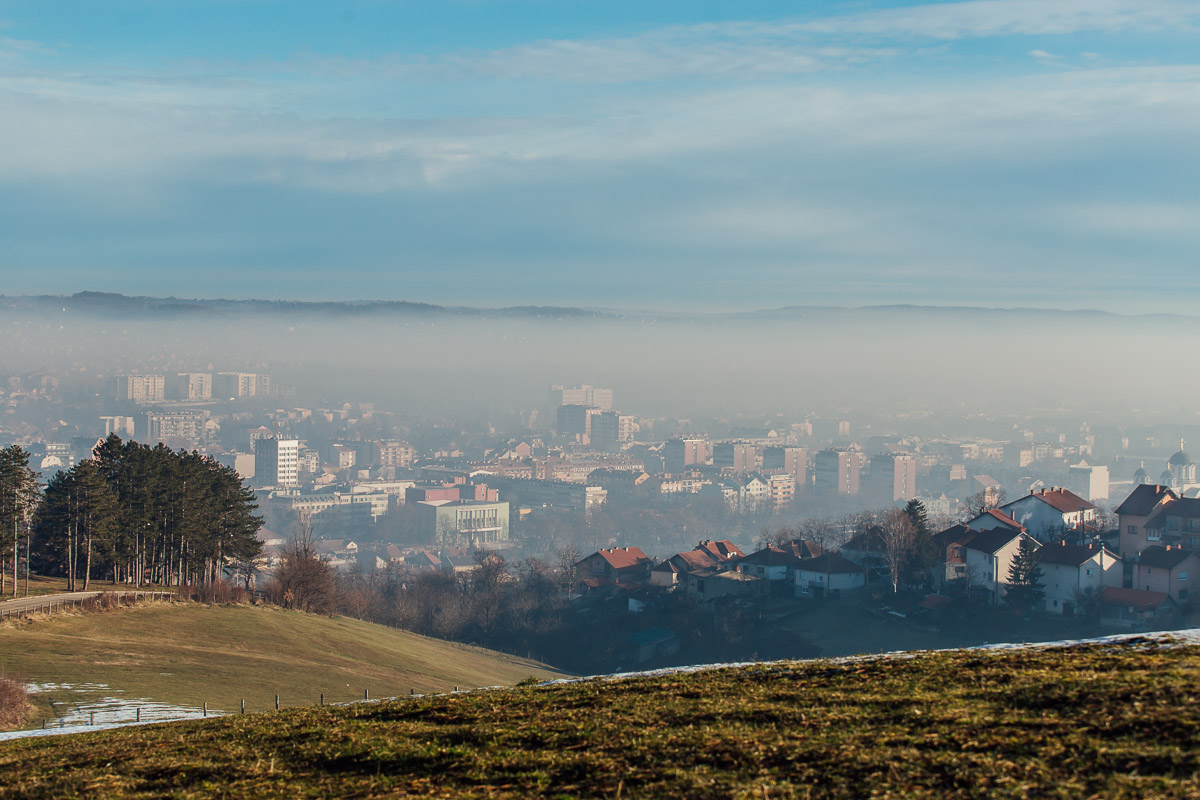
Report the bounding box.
[0,603,557,723]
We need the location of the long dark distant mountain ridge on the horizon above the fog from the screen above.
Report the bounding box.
[0,291,1194,321]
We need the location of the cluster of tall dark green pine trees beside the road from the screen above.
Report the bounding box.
[0,435,262,595]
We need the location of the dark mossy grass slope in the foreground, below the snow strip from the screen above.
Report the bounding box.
[0,639,1200,799]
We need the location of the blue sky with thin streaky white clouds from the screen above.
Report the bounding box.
[0,0,1200,313]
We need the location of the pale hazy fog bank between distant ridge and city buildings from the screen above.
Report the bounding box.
[0,295,1200,421]
